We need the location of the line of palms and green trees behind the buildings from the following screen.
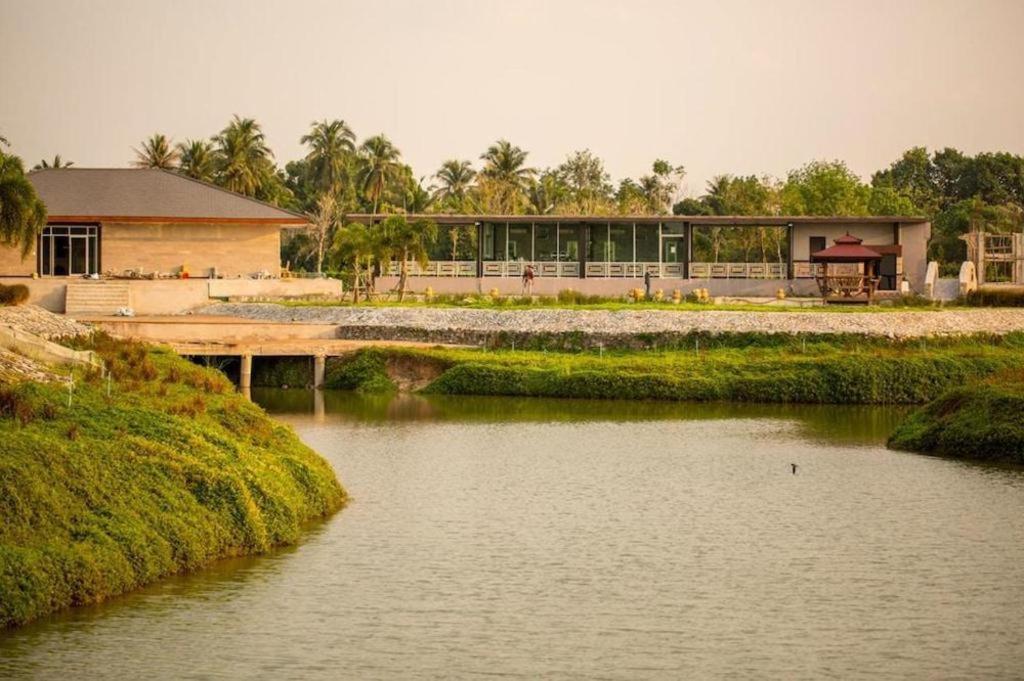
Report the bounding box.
[4,116,1024,271]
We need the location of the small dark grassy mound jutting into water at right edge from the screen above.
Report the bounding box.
[889,370,1024,464]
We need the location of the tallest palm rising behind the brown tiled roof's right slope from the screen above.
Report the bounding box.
[211,114,273,197]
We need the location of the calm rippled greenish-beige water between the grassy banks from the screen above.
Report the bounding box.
[0,392,1024,679]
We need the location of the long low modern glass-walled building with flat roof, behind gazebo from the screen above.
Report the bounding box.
[348,214,931,290]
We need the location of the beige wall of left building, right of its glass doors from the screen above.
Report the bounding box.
[100,223,281,276]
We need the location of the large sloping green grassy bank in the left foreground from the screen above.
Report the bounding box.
[0,338,345,627]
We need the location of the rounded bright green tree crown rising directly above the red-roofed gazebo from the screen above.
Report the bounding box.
[781,161,870,215]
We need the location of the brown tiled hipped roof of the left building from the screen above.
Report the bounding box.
[29,168,307,224]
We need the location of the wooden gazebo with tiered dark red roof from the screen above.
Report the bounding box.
[811,232,882,304]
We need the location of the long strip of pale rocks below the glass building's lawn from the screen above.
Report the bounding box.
[203,303,1024,343]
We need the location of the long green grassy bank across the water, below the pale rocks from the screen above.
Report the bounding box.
[327,334,1024,405]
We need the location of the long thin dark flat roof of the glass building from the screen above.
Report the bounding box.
[345,213,928,225]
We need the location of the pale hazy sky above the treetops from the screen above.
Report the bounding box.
[0,0,1024,194]
